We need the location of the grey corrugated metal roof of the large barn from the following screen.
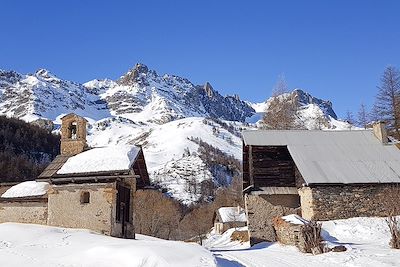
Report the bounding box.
[242,130,400,184]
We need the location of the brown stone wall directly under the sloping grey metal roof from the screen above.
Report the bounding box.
[299,184,400,220]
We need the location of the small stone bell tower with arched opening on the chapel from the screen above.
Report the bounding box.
[61,113,87,156]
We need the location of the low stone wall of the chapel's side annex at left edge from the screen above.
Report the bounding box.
[0,198,47,224]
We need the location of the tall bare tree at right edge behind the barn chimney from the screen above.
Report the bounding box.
[374,66,400,137]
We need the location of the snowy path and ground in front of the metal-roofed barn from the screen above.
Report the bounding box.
[205,217,400,267]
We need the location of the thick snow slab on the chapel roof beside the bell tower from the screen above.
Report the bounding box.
[57,146,140,174]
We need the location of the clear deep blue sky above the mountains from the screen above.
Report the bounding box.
[0,0,400,117]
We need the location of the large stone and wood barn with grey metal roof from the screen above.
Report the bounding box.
[242,123,400,245]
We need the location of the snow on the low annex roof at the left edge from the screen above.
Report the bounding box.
[1,181,49,198]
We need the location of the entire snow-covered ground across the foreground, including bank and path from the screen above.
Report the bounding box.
[0,217,400,267]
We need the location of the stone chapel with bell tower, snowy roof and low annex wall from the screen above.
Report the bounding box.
[0,114,150,238]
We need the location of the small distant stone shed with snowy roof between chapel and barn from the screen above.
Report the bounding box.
[214,206,247,234]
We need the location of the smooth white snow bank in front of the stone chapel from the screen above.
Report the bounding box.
[0,223,216,267]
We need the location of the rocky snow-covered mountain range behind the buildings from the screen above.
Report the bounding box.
[0,64,345,203]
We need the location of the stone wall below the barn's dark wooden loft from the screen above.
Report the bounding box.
[245,195,299,244]
